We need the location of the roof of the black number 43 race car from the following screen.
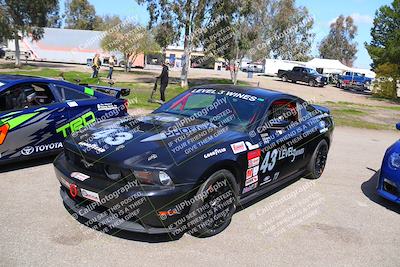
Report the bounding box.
[191,84,287,98]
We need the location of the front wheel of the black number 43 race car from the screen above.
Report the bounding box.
[189,170,238,238]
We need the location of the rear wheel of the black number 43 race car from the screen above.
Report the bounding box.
[305,140,329,179]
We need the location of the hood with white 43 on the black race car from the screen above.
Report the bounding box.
[64,113,243,168]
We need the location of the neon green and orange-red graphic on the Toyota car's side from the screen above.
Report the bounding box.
[0,108,47,145]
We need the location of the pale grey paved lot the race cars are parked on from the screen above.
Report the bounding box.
[0,128,400,266]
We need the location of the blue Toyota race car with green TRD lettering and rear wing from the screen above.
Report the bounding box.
[0,75,129,164]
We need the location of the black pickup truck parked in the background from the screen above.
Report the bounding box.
[278,67,328,87]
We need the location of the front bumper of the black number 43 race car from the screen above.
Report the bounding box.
[54,153,196,234]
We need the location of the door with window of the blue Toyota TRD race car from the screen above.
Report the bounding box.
[0,83,66,161]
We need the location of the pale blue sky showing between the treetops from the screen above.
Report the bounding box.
[61,0,392,68]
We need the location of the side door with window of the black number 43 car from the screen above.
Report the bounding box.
[259,98,304,186]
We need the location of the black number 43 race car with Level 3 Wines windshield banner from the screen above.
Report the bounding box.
[54,85,334,237]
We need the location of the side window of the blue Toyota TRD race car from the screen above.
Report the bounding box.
[0,83,55,111]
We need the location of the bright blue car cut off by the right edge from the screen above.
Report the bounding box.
[378,123,400,204]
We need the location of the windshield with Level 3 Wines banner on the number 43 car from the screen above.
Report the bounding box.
[156,89,264,127]
